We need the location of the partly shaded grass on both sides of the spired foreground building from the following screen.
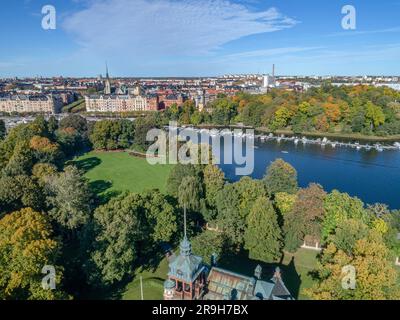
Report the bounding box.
[121,249,318,300]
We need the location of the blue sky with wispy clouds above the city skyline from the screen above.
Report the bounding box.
[0,0,400,77]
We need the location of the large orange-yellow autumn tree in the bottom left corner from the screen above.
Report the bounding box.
[0,208,66,300]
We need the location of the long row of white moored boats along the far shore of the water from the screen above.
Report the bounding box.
[180,128,400,152]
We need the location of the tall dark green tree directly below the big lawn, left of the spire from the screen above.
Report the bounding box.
[87,194,145,286]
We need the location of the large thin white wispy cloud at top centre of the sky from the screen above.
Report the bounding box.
[63,0,297,57]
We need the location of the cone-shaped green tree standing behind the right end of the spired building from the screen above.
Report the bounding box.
[244,197,282,263]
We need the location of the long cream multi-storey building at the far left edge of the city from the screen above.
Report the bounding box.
[0,95,64,114]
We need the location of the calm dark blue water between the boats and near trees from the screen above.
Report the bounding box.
[220,141,400,209]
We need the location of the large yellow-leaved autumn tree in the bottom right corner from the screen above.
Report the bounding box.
[304,227,400,300]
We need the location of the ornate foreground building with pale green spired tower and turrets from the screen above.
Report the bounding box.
[164,213,294,300]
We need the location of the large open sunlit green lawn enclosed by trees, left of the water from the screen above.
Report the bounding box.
[73,152,171,194]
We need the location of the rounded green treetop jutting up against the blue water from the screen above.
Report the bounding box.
[264,159,298,195]
